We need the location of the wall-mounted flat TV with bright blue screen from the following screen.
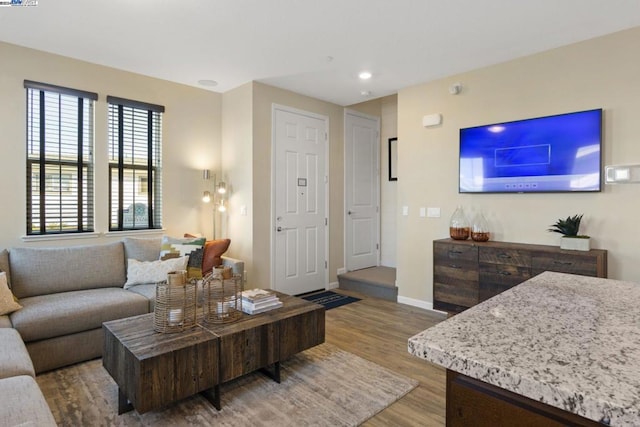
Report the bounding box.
[459,109,602,193]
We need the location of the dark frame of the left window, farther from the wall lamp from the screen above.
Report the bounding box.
[23,80,98,236]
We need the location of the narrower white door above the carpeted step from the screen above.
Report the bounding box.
[344,111,380,271]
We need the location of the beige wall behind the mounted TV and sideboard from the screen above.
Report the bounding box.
[397,29,640,305]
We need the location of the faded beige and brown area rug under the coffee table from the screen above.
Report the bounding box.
[36,343,418,426]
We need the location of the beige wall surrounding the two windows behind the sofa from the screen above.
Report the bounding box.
[0,42,222,247]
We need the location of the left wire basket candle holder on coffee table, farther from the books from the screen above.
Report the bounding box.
[153,281,197,333]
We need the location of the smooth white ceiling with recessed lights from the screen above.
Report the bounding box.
[0,0,640,105]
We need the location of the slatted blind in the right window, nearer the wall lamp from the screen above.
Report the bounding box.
[107,96,164,231]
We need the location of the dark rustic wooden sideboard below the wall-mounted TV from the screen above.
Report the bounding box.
[433,239,607,313]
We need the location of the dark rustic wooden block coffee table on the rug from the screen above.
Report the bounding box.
[102,294,325,414]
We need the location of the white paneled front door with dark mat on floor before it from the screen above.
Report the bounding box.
[272,106,328,295]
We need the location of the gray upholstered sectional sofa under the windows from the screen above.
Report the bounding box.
[0,238,244,425]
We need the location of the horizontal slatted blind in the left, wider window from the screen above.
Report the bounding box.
[24,80,98,235]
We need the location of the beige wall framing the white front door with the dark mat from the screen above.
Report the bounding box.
[250,82,344,288]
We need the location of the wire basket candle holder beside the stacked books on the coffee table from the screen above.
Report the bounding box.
[202,274,242,323]
